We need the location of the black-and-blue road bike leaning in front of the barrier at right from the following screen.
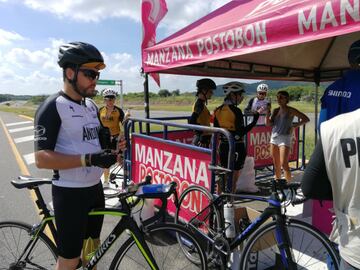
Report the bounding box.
[175,167,339,270]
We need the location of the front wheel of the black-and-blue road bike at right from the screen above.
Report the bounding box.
[239,219,339,270]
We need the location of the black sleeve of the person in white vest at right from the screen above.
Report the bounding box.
[301,139,333,200]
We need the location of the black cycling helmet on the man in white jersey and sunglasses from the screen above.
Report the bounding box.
[58,42,105,69]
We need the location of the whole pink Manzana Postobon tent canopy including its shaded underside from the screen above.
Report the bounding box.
[142,0,360,81]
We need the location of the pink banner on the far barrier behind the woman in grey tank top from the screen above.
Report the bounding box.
[247,126,299,168]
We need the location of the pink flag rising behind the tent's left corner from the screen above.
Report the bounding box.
[141,0,167,86]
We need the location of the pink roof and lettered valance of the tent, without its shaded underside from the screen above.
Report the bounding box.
[142,0,360,72]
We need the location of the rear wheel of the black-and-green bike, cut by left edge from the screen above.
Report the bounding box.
[0,221,57,270]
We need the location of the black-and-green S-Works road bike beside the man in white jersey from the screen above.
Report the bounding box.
[0,176,207,270]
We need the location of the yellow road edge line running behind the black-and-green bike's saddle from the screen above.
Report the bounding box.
[0,115,55,243]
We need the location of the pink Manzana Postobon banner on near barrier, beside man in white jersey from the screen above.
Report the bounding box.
[131,134,211,220]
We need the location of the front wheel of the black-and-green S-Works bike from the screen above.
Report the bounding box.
[110,223,207,270]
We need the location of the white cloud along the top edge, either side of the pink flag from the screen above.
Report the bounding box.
[24,0,230,33]
